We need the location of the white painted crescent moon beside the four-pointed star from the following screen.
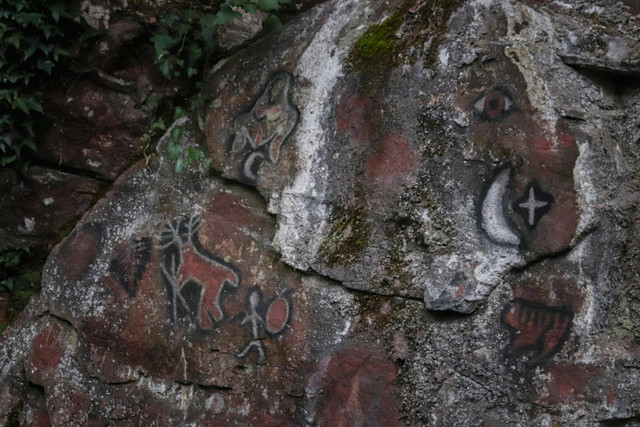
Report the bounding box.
[481,168,520,246]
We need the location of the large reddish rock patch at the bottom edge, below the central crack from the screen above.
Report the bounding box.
[317,347,399,427]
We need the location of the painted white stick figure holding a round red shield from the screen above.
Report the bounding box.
[237,286,292,364]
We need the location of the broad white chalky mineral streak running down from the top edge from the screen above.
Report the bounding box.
[273,0,363,270]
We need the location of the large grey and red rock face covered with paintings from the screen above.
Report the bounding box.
[0,0,640,426]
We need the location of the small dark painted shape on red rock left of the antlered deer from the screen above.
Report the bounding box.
[109,236,151,297]
